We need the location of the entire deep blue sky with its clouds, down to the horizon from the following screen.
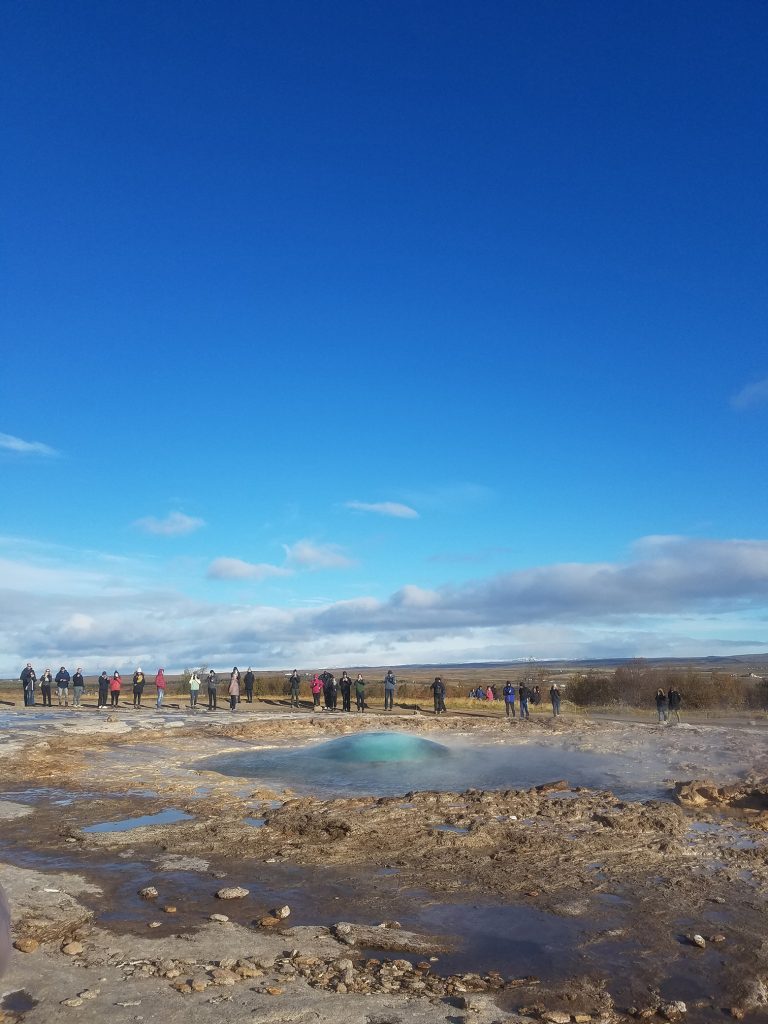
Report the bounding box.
[0,0,768,674]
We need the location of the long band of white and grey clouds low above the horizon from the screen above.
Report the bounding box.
[0,537,768,677]
